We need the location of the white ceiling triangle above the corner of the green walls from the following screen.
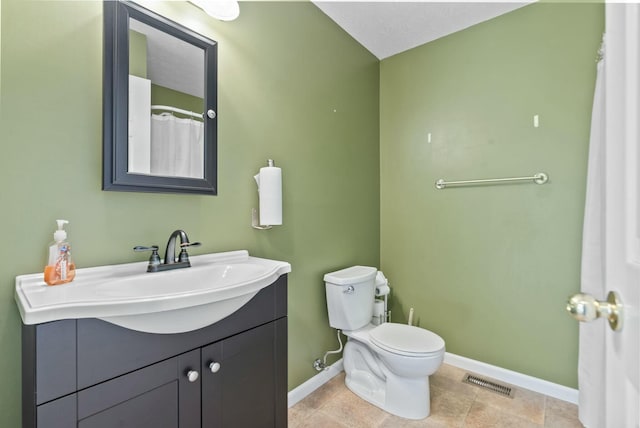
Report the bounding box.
[312,0,535,59]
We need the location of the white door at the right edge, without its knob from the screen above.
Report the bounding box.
[604,3,640,428]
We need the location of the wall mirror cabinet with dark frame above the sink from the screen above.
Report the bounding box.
[102,0,217,195]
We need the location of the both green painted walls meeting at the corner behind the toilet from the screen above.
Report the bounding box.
[0,0,603,427]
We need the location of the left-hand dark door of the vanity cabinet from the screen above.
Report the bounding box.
[78,350,200,428]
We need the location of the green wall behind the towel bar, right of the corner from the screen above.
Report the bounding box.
[380,0,604,387]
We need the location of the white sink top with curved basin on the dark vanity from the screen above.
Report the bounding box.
[15,251,291,333]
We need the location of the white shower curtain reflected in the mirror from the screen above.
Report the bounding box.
[151,113,204,178]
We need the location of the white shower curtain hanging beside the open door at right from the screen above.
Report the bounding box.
[578,41,608,428]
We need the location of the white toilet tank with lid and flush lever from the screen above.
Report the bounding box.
[324,266,378,331]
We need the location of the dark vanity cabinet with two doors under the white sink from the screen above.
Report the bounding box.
[22,275,287,428]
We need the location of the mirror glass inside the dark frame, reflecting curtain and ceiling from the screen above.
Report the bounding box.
[128,19,204,178]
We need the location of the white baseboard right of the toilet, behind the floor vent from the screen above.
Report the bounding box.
[444,352,578,404]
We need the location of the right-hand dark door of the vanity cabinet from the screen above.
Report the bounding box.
[202,322,278,428]
